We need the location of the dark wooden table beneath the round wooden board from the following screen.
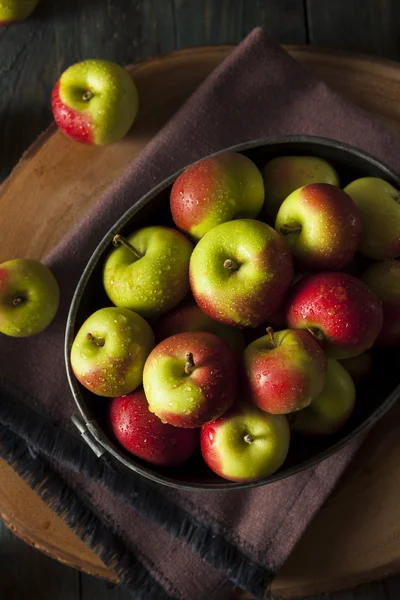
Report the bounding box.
[0,0,400,600]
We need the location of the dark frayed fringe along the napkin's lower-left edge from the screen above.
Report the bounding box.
[0,382,275,600]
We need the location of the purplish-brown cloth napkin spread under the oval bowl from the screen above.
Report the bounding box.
[0,29,400,600]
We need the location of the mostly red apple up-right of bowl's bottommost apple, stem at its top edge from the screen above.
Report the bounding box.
[244,327,326,414]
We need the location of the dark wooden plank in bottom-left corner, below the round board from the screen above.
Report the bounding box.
[0,520,79,600]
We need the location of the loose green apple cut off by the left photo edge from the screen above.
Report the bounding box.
[0,258,60,337]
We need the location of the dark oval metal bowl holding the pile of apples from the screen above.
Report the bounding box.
[65,136,400,490]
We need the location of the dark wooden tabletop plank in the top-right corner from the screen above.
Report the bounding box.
[305,0,400,59]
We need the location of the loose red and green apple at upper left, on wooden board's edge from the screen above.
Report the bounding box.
[51,59,138,146]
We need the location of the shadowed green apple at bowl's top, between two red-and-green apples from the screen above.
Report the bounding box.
[262,156,339,223]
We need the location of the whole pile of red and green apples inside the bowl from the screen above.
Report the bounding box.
[71,152,400,481]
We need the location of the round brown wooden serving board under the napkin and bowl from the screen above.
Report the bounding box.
[0,46,400,599]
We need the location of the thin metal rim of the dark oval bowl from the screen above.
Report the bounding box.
[64,135,400,492]
